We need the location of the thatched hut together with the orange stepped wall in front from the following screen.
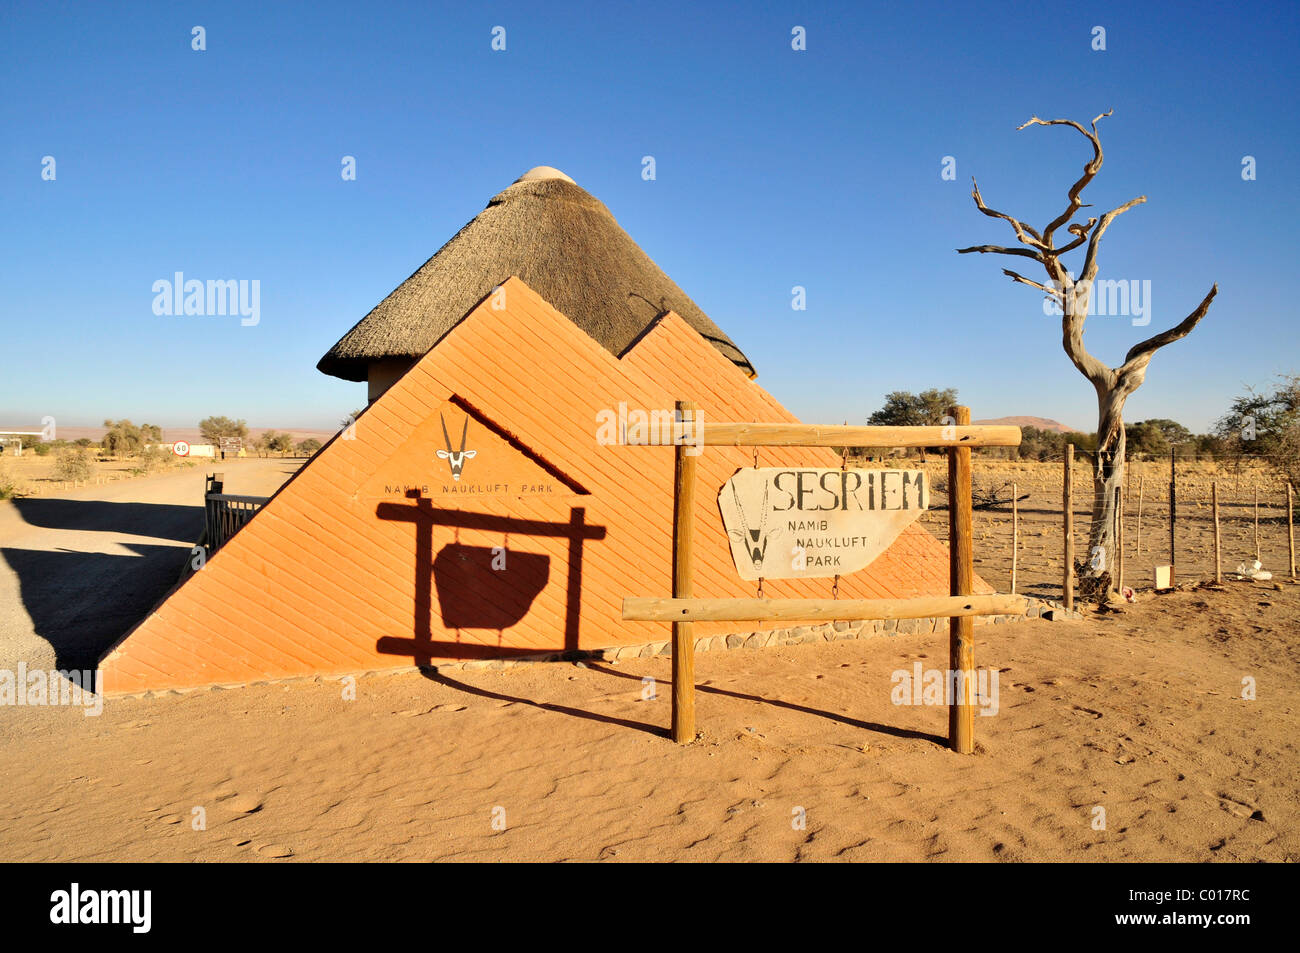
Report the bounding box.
[101,169,988,693]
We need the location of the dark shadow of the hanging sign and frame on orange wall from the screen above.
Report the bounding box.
[376,490,606,667]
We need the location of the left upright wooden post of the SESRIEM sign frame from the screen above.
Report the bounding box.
[672,400,699,745]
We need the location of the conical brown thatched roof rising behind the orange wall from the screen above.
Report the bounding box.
[316,166,754,381]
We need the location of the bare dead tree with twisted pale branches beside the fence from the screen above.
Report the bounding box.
[957,111,1218,594]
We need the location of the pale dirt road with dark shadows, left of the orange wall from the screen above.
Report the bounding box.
[0,459,302,670]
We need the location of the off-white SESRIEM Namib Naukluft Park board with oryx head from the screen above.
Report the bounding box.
[718,467,930,580]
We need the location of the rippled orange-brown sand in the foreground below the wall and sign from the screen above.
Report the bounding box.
[0,584,1300,861]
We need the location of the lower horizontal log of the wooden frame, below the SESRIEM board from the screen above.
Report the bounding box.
[623,593,1028,623]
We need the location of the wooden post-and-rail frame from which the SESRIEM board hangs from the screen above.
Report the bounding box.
[623,402,1027,754]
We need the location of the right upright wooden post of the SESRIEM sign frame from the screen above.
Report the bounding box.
[948,407,975,754]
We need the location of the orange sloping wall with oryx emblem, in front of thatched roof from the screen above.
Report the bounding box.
[101,278,989,693]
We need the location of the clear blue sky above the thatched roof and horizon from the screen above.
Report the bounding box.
[0,1,1300,430]
